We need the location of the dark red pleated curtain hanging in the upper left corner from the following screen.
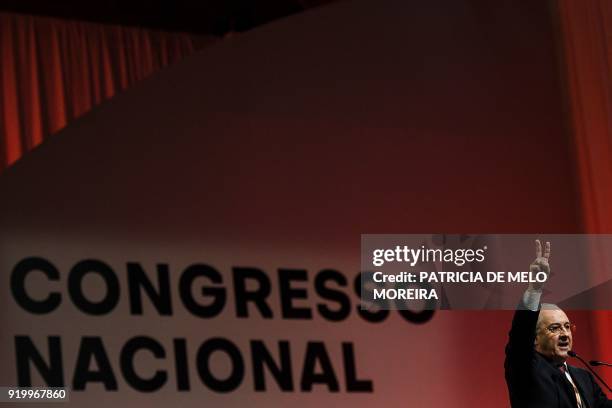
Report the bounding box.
[0,13,211,172]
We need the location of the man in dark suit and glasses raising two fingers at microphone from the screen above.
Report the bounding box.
[504,241,612,408]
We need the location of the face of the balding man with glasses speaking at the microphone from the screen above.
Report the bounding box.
[535,309,572,363]
